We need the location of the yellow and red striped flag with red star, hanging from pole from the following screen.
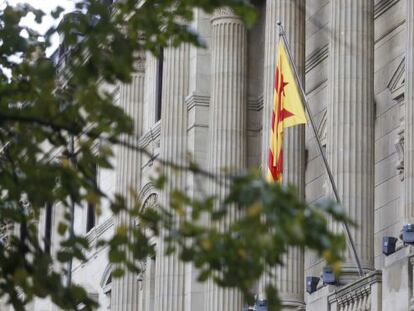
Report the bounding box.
[267,40,306,182]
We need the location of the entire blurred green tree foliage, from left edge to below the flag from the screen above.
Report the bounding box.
[0,0,346,310]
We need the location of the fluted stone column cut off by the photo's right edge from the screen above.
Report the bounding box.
[404,0,414,224]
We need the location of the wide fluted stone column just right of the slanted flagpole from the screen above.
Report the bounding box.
[327,0,374,277]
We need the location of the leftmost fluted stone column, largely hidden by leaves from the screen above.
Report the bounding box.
[111,56,145,311]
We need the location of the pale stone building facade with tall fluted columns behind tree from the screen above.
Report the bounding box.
[26,0,414,311]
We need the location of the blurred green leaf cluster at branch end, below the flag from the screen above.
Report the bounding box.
[154,173,348,310]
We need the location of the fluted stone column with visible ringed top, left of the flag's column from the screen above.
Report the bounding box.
[207,8,247,311]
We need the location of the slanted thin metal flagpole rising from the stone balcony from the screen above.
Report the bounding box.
[277,21,364,277]
